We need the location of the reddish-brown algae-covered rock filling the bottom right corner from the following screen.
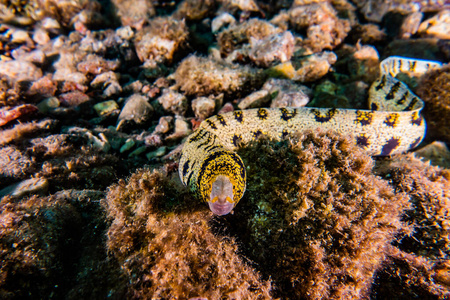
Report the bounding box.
[373,154,450,299]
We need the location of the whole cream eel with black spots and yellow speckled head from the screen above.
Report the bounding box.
[179,57,441,215]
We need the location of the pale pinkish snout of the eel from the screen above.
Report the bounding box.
[208,175,234,216]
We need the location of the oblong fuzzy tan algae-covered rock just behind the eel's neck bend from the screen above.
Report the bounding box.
[174,55,265,97]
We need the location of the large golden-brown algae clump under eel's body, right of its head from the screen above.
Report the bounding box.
[214,132,409,299]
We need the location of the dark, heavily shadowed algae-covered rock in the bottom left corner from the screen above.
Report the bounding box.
[0,190,124,299]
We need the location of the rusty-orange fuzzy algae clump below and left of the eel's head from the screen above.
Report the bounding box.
[104,170,270,299]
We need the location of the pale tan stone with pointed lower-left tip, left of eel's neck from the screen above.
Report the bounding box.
[116,94,154,130]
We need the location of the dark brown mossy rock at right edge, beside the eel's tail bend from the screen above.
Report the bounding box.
[417,66,450,143]
